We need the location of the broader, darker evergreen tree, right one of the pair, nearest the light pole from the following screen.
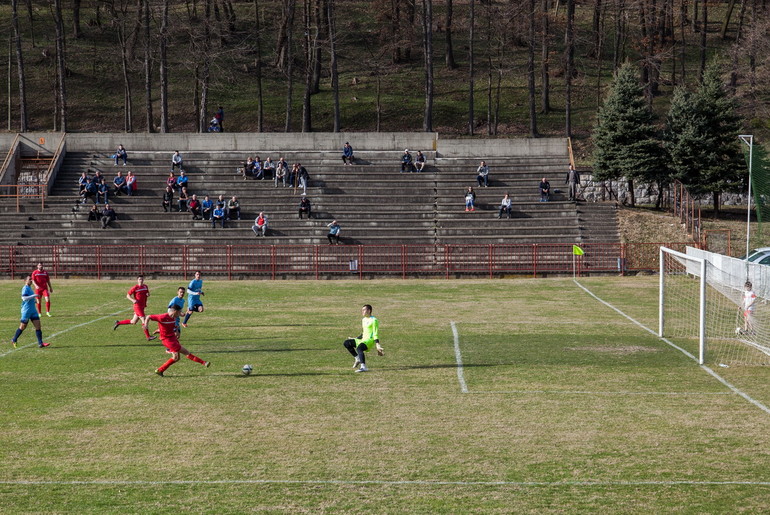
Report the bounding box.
[664,62,747,213]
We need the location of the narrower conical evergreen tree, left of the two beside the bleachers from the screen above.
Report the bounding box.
[593,63,669,206]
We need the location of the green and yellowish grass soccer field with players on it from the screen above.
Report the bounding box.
[0,276,770,513]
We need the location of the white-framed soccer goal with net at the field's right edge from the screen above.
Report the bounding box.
[659,247,770,366]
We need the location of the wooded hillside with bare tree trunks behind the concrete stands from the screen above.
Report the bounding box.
[0,0,770,138]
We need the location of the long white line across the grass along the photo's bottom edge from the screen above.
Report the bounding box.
[0,479,770,487]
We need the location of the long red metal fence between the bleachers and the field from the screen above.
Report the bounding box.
[0,243,687,279]
